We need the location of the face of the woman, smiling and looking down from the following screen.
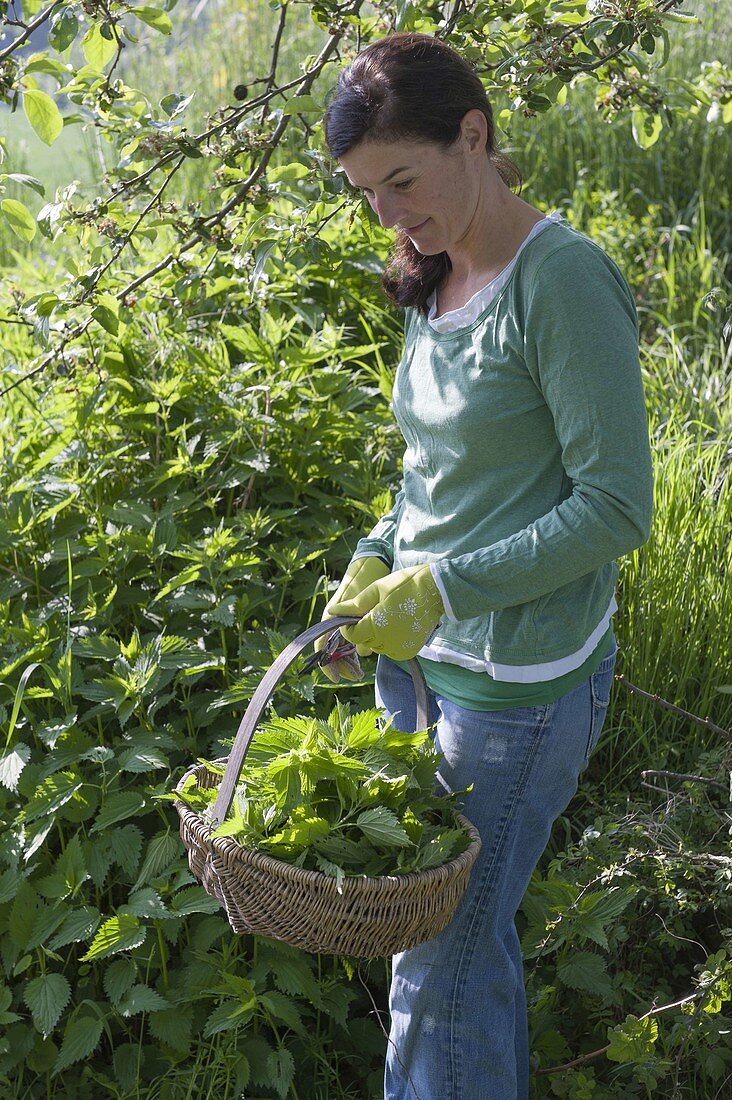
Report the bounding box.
[340,122,488,255]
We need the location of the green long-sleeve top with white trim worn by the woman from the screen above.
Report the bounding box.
[357,221,652,681]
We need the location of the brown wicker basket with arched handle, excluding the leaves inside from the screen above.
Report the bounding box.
[175,618,480,958]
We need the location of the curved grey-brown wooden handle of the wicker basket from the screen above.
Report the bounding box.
[212,615,429,828]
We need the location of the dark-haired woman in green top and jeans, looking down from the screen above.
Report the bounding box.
[324,34,652,1100]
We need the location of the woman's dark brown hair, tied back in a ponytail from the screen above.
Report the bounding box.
[325,34,522,312]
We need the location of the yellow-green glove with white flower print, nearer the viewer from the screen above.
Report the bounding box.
[330,565,445,661]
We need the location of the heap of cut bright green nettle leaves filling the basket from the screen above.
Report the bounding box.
[176,704,469,888]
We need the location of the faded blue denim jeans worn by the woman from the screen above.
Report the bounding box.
[376,651,615,1100]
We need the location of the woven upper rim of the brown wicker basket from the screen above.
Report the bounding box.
[173,758,481,899]
